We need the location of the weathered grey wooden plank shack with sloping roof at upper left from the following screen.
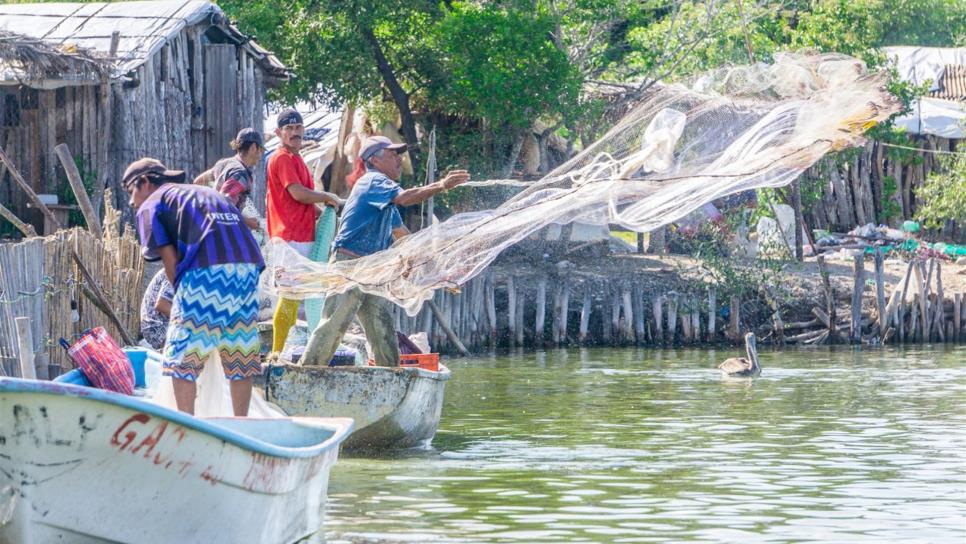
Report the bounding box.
[0,0,289,231]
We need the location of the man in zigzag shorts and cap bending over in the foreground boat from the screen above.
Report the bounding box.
[122,158,265,416]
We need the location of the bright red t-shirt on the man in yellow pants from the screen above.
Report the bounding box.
[268,147,315,242]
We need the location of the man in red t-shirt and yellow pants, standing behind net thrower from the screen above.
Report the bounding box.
[267,108,342,352]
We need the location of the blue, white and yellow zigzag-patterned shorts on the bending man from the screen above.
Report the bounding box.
[163,264,261,381]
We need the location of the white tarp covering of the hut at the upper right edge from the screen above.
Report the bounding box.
[883,46,966,139]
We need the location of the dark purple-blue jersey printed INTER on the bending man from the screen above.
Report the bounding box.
[137,183,265,288]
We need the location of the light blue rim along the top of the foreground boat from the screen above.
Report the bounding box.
[0,378,353,459]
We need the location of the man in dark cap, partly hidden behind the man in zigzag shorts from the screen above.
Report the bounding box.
[194,127,265,230]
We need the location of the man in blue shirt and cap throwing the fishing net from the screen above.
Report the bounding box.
[303,136,470,366]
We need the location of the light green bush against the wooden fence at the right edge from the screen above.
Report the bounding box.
[916,153,966,229]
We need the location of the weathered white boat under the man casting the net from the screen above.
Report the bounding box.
[265,364,451,451]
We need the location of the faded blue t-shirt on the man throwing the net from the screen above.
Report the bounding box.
[332,171,402,256]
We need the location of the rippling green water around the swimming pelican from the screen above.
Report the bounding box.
[326,348,966,543]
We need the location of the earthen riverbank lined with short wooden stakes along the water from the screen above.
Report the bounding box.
[397,250,966,353]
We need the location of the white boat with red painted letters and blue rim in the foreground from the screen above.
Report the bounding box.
[0,378,352,544]
